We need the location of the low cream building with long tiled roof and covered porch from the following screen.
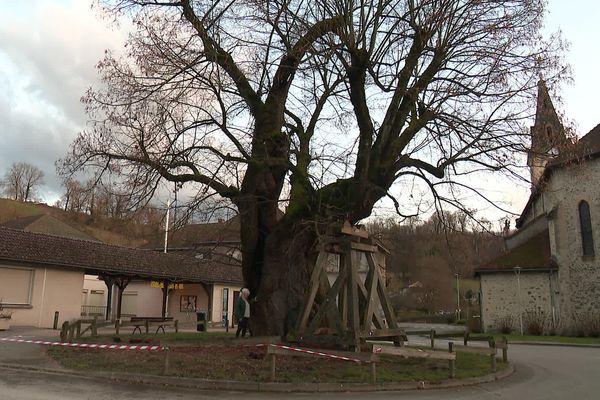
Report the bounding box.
[0,227,242,328]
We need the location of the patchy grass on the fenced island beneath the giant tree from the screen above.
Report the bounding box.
[48,333,506,383]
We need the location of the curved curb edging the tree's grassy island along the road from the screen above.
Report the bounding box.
[0,363,515,393]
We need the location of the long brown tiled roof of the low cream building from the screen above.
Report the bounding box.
[0,227,243,285]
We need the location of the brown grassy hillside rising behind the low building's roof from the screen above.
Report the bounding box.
[0,199,153,247]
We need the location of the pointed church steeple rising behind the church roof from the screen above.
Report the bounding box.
[527,79,568,190]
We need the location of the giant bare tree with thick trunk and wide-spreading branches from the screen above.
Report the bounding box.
[60,0,563,334]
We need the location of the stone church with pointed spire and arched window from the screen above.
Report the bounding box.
[476,81,600,334]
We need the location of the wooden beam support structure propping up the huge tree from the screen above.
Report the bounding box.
[296,224,406,352]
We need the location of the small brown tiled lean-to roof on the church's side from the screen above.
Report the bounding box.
[475,230,558,275]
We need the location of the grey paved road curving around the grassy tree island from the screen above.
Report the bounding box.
[0,345,600,400]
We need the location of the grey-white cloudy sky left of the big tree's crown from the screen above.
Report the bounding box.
[0,0,125,201]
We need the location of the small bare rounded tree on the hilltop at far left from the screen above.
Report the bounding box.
[2,162,44,201]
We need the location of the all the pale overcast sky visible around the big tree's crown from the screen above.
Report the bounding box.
[0,0,600,220]
